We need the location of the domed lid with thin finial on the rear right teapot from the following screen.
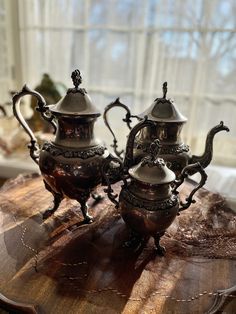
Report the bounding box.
[138,82,187,122]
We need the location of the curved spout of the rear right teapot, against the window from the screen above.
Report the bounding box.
[189,121,229,168]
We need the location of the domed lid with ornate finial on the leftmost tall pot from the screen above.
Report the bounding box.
[48,70,101,117]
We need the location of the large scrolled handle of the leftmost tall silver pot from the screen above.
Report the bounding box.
[12,85,56,164]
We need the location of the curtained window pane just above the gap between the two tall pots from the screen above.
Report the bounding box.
[89,30,136,88]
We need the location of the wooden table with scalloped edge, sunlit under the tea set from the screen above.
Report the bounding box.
[0,175,236,314]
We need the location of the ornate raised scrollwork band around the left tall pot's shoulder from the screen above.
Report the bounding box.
[42,142,106,159]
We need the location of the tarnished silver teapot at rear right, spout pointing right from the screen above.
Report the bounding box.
[103,82,229,175]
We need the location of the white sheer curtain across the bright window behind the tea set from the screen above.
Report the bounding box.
[12,0,236,165]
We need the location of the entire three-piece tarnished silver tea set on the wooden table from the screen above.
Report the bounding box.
[13,70,229,254]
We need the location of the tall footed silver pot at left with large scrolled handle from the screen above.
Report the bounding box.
[13,70,109,223]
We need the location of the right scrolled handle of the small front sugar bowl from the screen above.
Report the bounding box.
[173,162,207,211]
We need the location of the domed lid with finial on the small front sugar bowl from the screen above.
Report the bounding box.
[129,140,176,184]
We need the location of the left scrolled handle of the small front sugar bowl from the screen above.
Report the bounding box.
[101,154,127,208]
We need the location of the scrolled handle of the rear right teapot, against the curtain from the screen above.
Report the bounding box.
[103,98,140,158]
